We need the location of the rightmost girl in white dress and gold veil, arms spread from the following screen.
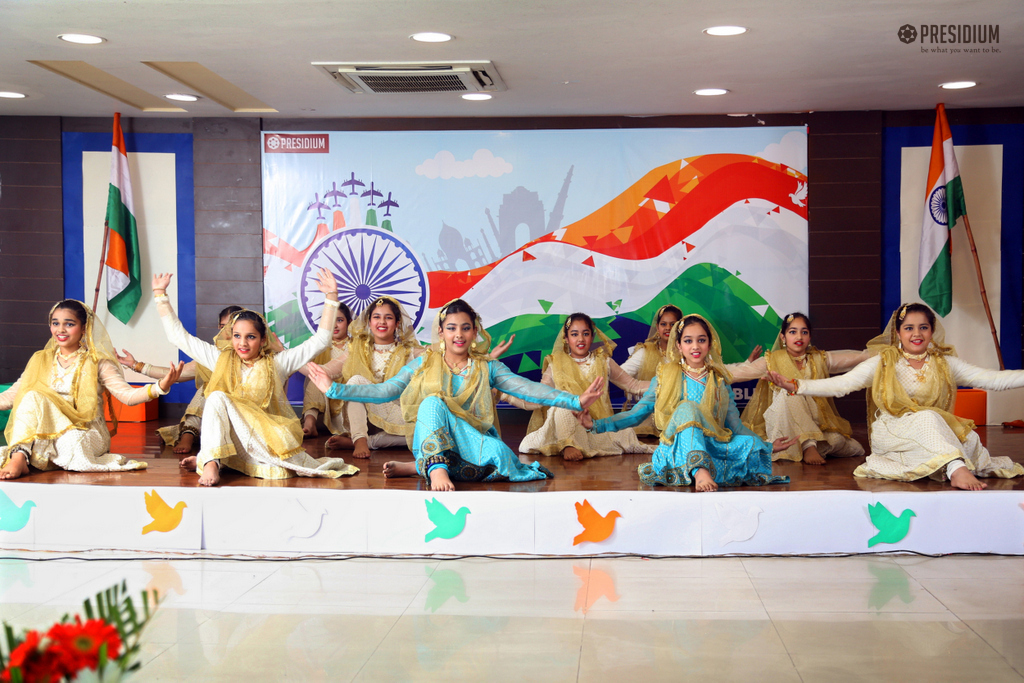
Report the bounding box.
[768,303,1024,490]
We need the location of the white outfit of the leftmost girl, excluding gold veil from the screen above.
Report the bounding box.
[0,355,165,472]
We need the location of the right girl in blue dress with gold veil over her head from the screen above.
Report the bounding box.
[581,315,794,492]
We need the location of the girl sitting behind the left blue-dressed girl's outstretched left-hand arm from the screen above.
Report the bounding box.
[327,296,423,458]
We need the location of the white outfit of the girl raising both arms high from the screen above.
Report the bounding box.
[157,297,359,479]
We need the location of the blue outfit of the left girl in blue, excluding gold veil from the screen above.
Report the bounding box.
[327,356,580,481]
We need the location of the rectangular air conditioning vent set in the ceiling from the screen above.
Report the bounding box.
[312,61,506,94]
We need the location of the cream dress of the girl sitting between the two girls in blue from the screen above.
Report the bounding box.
[516,354,654,458]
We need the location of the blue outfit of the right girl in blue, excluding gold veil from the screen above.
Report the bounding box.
[592,375,790,486]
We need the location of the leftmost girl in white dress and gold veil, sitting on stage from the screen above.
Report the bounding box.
[0,299,183,479]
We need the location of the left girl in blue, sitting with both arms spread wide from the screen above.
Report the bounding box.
[308,299,603,490]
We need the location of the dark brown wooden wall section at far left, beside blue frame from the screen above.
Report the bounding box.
[0,117,63,383]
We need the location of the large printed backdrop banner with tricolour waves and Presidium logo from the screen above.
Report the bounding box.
[262,127,808,387]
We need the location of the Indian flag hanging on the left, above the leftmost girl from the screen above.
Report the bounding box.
[104,114,142,324]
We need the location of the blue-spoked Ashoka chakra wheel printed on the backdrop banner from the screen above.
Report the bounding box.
[299,227,429,331]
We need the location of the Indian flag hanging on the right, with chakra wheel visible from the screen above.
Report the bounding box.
[918,104,967,316]
